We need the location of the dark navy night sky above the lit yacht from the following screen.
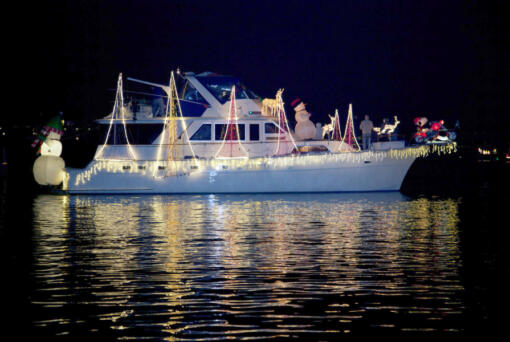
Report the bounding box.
[2,0,510,146]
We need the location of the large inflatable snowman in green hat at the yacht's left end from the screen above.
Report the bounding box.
[33,116,65,185]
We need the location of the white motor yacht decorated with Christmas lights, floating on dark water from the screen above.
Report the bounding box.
[35,72,436,194]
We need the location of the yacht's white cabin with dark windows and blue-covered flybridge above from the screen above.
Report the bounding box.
[96,72,329,160]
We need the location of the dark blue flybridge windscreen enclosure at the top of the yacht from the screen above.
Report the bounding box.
[197,76,259,104]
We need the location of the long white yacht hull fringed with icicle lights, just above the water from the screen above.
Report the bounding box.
[64,152,416,194]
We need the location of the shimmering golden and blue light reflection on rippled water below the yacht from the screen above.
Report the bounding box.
[31,193,464,340]
